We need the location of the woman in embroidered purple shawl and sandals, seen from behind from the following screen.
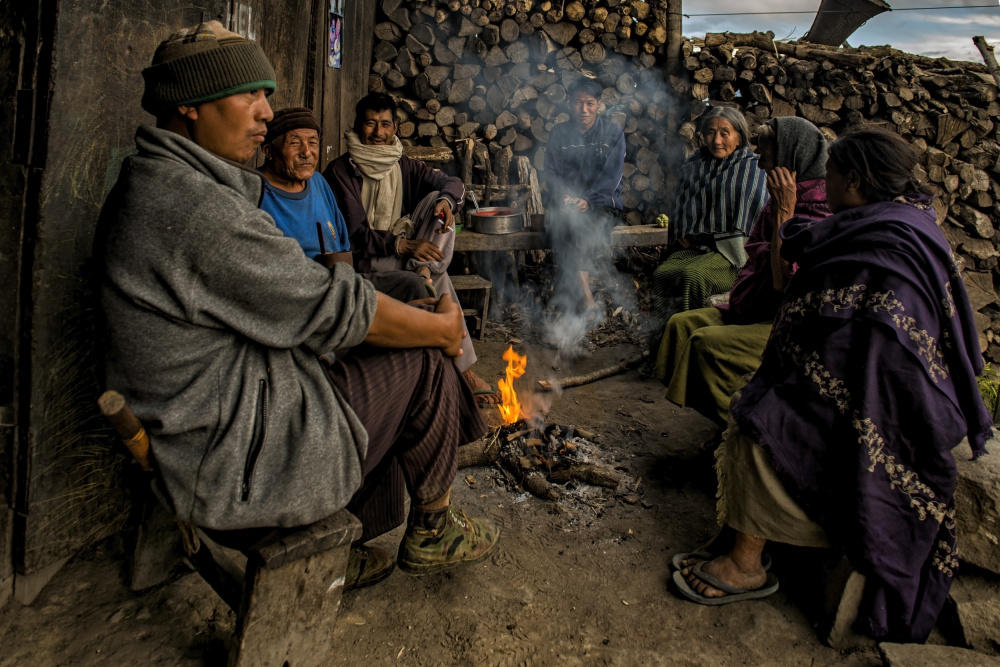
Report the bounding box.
[674,128,992,641]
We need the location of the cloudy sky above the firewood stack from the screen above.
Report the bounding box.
[684,0,1000,62]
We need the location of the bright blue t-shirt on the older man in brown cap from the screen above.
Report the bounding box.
[260,173,351,258]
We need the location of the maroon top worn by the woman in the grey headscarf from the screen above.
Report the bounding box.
[718,178,830,324]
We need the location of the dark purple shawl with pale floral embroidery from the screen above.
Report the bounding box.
[733,195,991,642]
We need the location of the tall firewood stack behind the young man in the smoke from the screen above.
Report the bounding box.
[369,0,668,224]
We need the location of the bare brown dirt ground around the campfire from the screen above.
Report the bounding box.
[0,342,881,667]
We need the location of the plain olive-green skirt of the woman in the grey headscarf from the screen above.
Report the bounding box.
[655,308,771,427]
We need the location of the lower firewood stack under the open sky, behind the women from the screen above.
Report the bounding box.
[671,33,1000,362]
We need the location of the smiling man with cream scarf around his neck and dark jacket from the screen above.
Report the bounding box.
[323,93,500,403]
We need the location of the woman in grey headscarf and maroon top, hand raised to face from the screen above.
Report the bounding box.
[655,117,830,428]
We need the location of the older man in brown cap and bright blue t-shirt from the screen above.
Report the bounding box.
[260,107,430,303]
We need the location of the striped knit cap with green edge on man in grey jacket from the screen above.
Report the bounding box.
[142,21,277,115]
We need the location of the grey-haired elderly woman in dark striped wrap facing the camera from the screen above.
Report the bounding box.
[650,107,768,358]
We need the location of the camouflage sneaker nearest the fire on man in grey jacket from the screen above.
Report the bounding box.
[398,505,500,574]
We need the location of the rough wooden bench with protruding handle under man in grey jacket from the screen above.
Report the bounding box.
[98,391,361,667]
